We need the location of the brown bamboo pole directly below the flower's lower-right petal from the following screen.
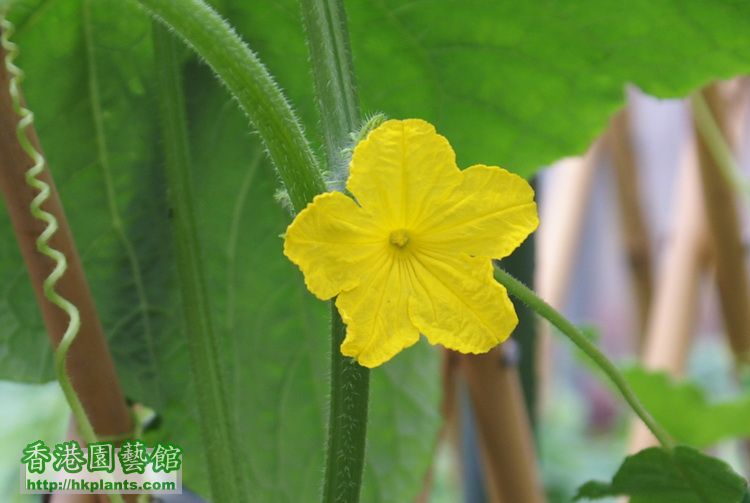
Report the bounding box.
[459,345,544,503]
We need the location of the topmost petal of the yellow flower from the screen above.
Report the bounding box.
[346,119,461,228]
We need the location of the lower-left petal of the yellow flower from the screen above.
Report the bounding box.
[336,252,419,368]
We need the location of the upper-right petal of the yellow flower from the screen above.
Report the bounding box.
[418,165,539,258]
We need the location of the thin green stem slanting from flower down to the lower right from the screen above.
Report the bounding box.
[495,267,674,452]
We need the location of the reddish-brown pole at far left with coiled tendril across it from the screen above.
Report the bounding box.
[0,37,132,437]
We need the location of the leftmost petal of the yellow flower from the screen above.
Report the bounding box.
[284,192,387,300]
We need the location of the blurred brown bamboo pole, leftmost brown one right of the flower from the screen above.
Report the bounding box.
[607,108,653,340]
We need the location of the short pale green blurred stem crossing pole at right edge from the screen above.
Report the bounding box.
[690,91,750,204]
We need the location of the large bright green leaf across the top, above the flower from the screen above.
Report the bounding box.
[226,0,750,175]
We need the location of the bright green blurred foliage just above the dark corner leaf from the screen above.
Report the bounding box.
[623,366,750,447]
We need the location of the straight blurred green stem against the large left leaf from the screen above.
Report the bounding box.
[153,23,247,501]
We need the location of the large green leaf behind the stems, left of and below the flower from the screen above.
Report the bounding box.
[0,0,439,502]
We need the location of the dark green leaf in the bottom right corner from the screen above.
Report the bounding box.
[575,446,747,503]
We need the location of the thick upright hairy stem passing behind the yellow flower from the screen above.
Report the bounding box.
[300,0,370,503]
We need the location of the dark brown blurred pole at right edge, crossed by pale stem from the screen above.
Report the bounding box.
[693,84,750,364]
